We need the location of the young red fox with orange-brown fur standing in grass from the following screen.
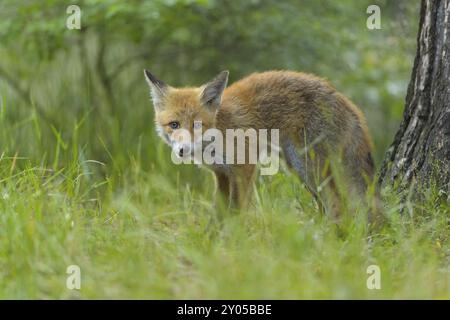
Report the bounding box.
[144,70,374,215]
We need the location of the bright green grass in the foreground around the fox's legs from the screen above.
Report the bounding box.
[0,150,450,299]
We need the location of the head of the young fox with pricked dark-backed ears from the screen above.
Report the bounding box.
[144,70,228,157]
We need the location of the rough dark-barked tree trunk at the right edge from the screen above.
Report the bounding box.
[380,0,450,194]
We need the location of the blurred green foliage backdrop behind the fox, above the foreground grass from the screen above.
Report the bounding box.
[0,0,419,185]
